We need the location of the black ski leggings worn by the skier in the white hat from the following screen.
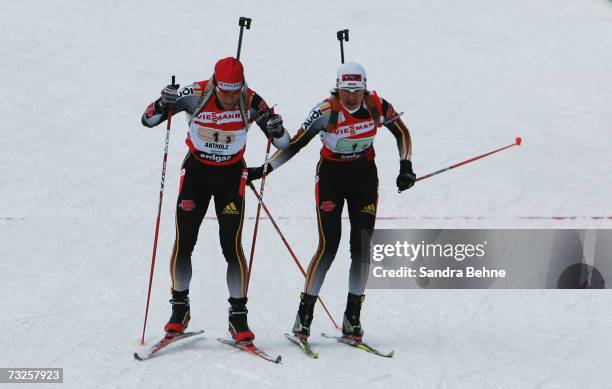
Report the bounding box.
[304,159,378,296]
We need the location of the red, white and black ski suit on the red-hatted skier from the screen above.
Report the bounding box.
[142,81,288,298]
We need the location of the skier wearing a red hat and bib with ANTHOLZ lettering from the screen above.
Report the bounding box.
[142,58,290,342]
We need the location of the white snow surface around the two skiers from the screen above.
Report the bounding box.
[0,0,612,389]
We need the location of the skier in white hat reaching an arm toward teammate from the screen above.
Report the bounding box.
[249,63,415,339]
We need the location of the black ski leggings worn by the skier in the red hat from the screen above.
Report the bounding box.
[170,154,247,298]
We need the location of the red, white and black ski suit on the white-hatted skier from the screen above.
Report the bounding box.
[270,92,411,296]
